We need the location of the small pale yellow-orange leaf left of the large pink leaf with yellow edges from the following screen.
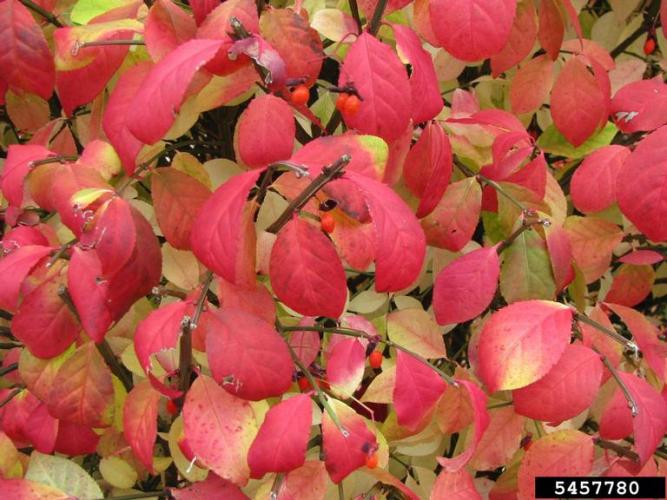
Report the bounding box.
[387,308,447,359]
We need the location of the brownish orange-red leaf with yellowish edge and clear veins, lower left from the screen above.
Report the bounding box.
[47,342,114,427]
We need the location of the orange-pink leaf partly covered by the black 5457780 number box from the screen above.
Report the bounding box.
[517,430,594,499]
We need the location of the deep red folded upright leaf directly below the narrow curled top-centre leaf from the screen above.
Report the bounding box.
[403,122,452,218]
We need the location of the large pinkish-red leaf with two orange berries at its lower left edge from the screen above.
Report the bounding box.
[338,32,411,141]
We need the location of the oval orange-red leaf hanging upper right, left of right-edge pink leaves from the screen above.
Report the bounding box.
[551,56,608,146]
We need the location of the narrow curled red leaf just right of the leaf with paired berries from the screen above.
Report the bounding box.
[391,24,442,123]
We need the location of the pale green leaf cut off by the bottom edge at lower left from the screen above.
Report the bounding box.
[25,451,104,500]
